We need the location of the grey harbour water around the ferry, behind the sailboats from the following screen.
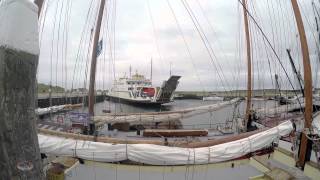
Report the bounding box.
[45,99,277,129]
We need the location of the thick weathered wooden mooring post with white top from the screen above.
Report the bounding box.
[0,0,44,179]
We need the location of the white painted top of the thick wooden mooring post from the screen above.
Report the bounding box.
[0,0,39,55]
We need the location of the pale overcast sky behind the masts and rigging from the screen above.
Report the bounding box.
[38,0,320,91]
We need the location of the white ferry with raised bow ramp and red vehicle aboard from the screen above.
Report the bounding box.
[107,72,181,106]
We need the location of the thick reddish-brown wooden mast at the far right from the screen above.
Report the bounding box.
[291,0,312,167]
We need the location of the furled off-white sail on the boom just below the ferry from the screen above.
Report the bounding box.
[93,98,240,124]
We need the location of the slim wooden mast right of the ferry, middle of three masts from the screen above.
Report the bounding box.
[242,0,252,129]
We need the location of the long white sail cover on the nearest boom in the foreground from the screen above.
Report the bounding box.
[38,121,293,165]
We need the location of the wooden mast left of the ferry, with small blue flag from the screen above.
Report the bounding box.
[88,0,106,134]
